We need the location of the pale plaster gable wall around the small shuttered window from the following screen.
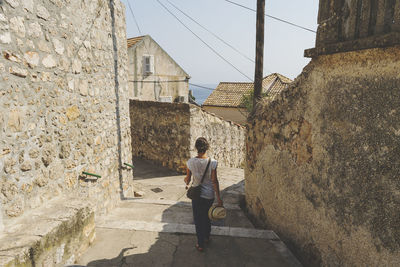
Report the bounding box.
[128,38,189,102]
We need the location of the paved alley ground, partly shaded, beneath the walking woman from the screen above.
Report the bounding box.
[75,160,300,267]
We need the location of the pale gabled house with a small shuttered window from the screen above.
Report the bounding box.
[127,35,190,103]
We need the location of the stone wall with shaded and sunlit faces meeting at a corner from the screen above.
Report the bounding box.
[130,100,245,172]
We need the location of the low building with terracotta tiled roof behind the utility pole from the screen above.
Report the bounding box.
[203,73,292,124]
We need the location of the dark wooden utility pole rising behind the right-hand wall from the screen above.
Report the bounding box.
[253,0,265,110]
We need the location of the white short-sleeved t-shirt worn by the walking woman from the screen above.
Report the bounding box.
[187,158,218,199]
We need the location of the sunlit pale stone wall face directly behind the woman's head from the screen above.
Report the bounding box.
[190,106,246,168]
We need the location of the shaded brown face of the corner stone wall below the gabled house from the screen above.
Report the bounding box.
[130,100,190,171]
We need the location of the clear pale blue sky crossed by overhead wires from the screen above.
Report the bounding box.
[122,0,319,84]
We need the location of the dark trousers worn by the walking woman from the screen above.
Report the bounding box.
[192,197,214,247]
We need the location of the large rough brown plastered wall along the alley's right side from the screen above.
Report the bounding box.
[245,47,400,266]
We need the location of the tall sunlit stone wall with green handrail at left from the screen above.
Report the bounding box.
[0,0,132,220]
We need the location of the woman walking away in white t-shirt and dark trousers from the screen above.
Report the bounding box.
[184,137,223,252]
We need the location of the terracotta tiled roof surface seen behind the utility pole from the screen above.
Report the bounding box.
[203,73,292,107]
